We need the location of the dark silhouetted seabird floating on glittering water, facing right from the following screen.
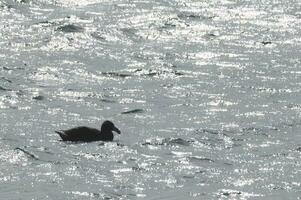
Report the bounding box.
[55,121,120,142]
